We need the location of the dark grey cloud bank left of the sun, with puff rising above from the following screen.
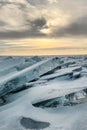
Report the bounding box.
[0,18,46,39]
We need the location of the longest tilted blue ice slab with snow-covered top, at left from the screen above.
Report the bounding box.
[0,57,60,97]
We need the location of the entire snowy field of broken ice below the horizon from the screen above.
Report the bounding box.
[0,56,87,130]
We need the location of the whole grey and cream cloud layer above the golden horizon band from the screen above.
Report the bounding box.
[0,0,87,39]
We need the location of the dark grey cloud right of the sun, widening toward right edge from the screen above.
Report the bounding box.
[53,16,87,37]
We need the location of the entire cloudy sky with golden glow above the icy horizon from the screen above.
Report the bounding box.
[0,0,87,56]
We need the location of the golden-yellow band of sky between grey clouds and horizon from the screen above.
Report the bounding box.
[0,39,87,56]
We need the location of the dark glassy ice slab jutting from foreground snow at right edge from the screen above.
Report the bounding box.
[33,89,87,107]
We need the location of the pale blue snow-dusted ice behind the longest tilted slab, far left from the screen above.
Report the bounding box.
[0,57,38,74]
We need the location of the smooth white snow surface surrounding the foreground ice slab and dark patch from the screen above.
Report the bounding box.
[0,56,87,130]
